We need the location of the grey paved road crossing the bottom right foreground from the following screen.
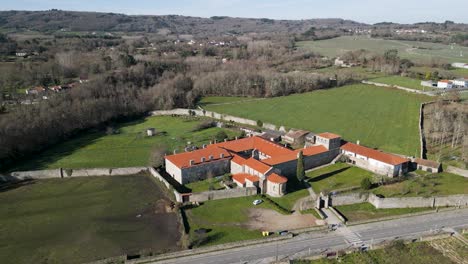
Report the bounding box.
[154,209,468,264]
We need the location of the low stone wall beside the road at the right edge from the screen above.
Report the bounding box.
[369,194,468,208]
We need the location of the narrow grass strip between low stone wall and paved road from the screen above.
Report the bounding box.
[335,203,433,222]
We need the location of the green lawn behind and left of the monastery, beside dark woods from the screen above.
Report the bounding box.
[13,116,240,170]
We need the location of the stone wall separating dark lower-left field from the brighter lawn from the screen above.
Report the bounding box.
[0,167,148,182]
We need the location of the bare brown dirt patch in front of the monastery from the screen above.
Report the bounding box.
[246,208,317,232]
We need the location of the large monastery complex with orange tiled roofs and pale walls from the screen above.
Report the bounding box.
[165,133,341,197]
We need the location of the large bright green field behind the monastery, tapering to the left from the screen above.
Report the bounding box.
[206,84,430,156]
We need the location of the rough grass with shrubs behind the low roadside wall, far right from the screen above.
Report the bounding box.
[373,172,468,197]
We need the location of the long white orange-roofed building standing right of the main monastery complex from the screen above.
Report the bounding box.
[341,142,409,177]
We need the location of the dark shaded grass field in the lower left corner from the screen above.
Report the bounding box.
[0,176,180,264]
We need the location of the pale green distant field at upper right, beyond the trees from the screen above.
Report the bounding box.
[297,36,468,62]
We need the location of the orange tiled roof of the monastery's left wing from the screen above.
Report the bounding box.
[166,145,231,168]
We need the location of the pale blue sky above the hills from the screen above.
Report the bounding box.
[0,0,468,23]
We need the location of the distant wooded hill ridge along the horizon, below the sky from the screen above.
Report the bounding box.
[0,10,365,35]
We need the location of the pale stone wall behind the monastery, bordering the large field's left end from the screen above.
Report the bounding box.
[150,108,278,130]
